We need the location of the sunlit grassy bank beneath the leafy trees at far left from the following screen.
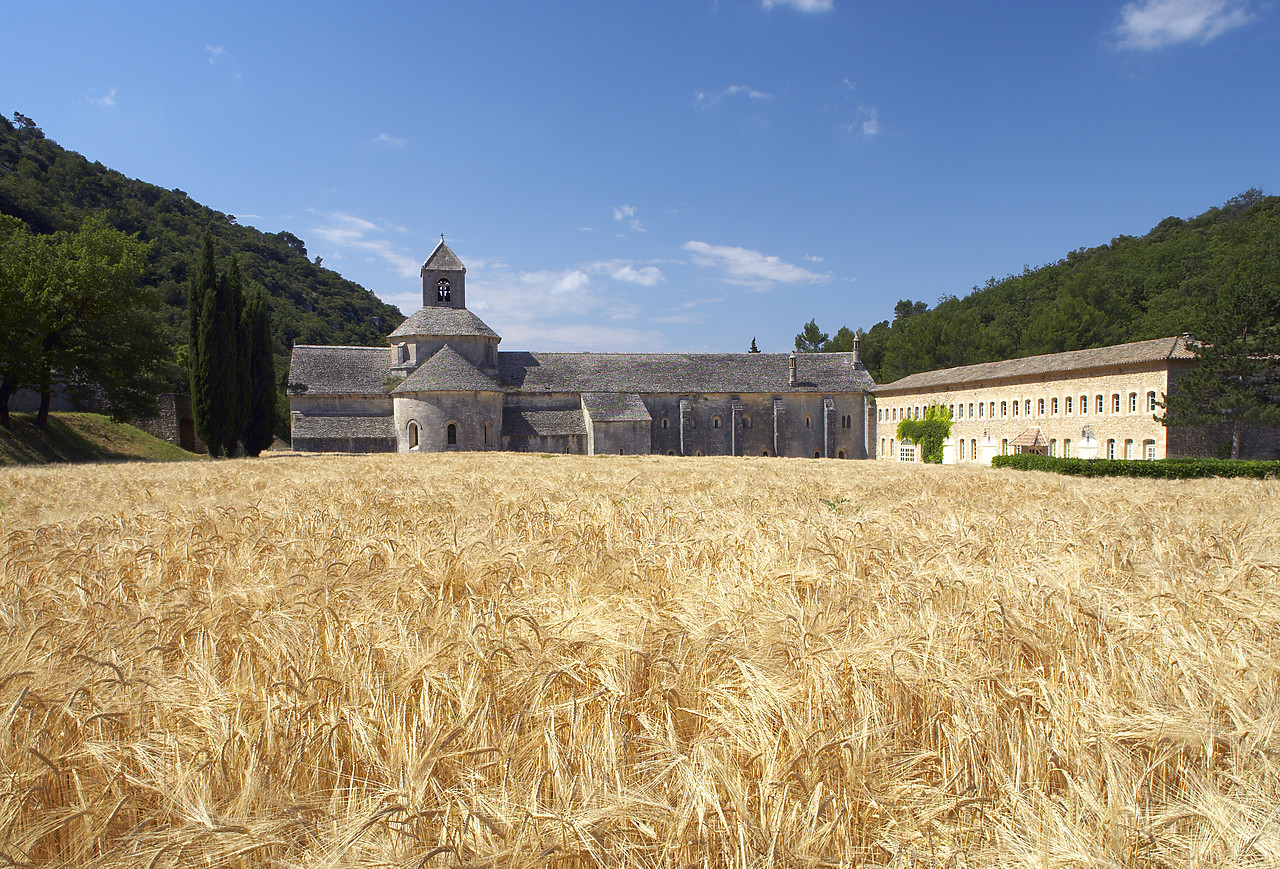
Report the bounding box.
[0,413,195,465]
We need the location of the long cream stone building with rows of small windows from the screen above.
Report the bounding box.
[874,337,1280,465]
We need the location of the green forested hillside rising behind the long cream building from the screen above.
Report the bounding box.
[824,189,1280,383]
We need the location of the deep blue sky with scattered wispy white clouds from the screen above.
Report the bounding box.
[0,0,1280,352]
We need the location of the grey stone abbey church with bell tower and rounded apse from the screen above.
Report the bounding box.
[288,239,874,458]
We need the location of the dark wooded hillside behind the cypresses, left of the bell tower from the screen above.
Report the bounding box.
[0,114,403,390]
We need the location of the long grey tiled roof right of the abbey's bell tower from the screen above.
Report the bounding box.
[498,352,876,394]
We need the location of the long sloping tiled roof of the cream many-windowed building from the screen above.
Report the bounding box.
[876,337,1196,394]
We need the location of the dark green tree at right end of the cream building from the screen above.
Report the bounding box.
[1158,278,1280,458]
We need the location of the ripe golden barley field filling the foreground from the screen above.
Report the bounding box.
[0,454,1280,869]
